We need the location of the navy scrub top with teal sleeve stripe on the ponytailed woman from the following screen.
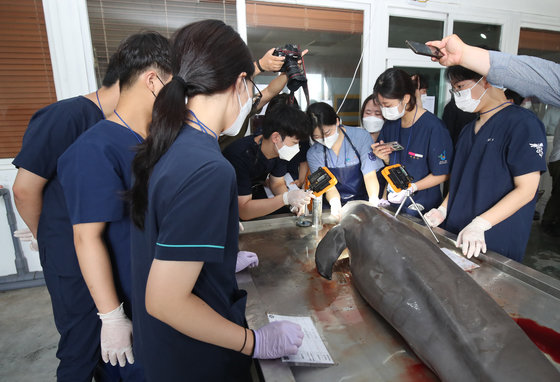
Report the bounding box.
[132,126,251,381]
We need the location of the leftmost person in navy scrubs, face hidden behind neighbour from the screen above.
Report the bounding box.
[13,46,126,382]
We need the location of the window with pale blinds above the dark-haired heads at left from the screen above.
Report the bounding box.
[87,0,237,85]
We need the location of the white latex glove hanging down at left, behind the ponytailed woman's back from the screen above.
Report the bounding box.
[97,303,134,367]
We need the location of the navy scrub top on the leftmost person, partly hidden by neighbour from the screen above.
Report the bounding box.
[13,96,103,277]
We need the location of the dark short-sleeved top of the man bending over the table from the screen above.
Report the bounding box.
[224,135,288,196]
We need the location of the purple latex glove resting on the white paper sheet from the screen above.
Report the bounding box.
[253,321,303,359]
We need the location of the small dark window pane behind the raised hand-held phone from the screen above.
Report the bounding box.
[389,16,443,48]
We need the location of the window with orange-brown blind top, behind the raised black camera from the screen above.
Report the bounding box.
[247,1,363,125]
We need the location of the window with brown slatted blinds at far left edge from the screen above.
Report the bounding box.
[0,0,56,158]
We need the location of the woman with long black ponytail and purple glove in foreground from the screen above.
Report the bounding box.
[128,20,303,382]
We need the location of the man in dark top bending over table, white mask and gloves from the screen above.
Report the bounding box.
[224,103,310,220]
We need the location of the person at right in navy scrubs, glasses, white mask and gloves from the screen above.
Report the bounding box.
[426,66,546,261]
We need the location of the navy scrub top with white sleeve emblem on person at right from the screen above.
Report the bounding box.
[445,105,546,261]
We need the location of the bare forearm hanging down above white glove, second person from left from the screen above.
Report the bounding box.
[74,228,120,313]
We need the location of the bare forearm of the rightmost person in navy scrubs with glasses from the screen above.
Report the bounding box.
[480,174,540,226]
